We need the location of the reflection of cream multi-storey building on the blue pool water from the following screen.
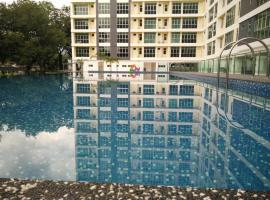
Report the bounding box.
[74,74,270,190]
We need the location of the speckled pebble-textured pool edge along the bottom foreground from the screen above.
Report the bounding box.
[0,179,270,200]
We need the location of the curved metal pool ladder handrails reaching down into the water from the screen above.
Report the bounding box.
[216,37,270,129]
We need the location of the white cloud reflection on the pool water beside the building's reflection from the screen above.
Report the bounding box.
[0,127,76,180]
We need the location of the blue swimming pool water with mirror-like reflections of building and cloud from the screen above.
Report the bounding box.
[0,75,270,191]
